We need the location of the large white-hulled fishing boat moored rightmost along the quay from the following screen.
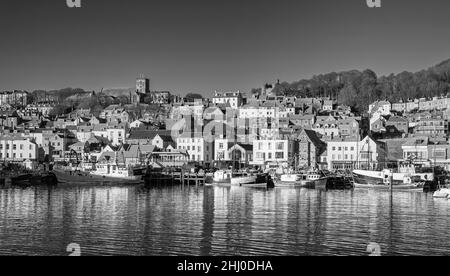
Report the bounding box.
[353,166,434,191]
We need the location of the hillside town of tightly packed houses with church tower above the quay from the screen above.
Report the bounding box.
[0,76,450,179]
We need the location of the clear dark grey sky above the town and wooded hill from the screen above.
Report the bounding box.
[0,0,450,96]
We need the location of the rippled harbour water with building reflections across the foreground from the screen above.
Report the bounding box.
[0,186,450,256]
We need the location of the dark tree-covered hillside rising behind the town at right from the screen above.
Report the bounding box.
[258,59,450,112]
